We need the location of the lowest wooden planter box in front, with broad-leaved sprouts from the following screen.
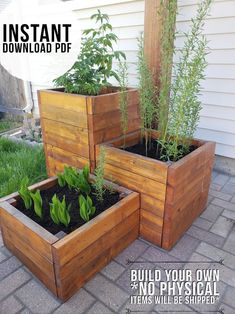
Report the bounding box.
[0,177,140,301]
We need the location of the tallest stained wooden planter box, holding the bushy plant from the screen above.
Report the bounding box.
[38,88,140,176]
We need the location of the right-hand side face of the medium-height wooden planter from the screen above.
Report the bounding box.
[162,142,215,250]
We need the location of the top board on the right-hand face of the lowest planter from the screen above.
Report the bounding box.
[53,193,140,265]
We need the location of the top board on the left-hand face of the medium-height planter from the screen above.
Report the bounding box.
[97,146,168,184]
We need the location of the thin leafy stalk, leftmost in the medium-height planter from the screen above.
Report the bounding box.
[118,62,128,148]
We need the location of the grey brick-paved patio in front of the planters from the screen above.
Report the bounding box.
[0,173,235,314]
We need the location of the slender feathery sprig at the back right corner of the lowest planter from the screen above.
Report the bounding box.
[93,147,106,202]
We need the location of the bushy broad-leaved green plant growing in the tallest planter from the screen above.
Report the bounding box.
[54,10,126,95]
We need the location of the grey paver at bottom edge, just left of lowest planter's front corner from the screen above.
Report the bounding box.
[16,279,61,314]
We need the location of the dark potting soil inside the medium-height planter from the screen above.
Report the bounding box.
[125,139,197,161]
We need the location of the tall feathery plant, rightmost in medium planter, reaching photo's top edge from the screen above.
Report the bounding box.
[160,0,212,161]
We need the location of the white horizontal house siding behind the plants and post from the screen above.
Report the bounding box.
[33,0,235,158]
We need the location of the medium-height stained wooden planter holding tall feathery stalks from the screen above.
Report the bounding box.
[96,132,215,250]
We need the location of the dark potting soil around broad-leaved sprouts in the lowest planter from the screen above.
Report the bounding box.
[16,185,120,235]
